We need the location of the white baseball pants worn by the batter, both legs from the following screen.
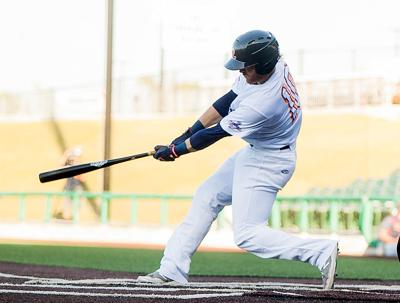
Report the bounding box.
[159,146,337,283]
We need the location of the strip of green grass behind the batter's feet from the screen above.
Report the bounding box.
[0,244,400,280]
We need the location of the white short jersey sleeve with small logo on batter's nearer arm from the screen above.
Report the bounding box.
[220,105,267,138]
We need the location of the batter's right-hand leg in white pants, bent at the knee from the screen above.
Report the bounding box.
[232,149,337,288]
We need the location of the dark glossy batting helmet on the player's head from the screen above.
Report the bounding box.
[225,30,280,75]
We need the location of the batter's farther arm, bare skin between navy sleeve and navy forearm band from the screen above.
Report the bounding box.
[171,90,237,145]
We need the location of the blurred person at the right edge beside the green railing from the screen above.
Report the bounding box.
[378,201,400,257]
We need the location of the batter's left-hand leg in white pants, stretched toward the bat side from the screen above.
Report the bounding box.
[144,152,240,283]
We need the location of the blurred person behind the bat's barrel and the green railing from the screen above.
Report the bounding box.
[54,146,83,220]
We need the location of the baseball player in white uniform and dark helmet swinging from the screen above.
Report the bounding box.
[138,30,338,289]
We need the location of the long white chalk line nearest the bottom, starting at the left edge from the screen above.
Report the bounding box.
[0,289,243,300]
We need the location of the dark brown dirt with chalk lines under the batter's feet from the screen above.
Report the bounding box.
[0,262,400,303]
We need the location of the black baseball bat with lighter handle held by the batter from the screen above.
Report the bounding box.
[39,151,155,183]
